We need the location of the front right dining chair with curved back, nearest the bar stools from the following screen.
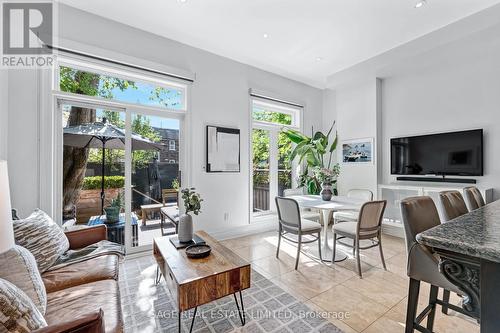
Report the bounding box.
[332,200,387,278]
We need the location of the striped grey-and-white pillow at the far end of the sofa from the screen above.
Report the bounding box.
[13,209,69,273]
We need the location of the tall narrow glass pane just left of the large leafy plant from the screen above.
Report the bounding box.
[252,129,271,214]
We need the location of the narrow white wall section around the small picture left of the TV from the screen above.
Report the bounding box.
[336,78,379,195]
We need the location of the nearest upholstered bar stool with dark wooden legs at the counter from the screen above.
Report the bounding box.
[401,196,465,333]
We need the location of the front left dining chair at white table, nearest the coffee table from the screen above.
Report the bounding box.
[275,197,322,270]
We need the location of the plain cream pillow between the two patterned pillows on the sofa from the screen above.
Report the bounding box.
[0,245,47,314]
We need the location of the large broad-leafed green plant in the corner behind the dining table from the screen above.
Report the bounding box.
[282,122,339,194]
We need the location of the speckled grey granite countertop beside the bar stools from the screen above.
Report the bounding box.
[417,200,500,263]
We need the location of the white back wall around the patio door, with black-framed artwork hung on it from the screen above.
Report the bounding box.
[4,6,323,231]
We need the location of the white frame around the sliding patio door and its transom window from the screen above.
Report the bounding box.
[50,55,192,253]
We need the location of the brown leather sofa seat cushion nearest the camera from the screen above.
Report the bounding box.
[45,280,123,333]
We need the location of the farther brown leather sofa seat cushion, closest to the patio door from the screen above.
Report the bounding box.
[42,254,119,293]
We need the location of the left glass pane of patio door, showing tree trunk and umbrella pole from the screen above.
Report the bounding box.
[61,104,125,245]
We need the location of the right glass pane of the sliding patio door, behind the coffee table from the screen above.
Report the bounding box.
[131,114,180,247]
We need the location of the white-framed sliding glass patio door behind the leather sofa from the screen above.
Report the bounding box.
[54,93,187,253]
